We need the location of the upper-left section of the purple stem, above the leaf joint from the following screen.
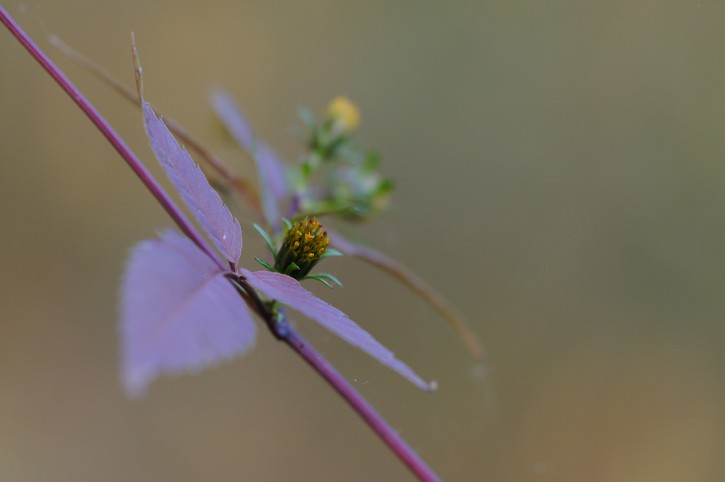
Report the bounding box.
[0,6,224,269]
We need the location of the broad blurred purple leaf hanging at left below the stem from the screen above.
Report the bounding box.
[120,231,256,396]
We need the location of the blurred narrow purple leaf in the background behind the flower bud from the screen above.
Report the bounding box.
[211,90,290,227]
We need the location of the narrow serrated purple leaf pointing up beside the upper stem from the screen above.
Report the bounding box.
[143,102,242,264]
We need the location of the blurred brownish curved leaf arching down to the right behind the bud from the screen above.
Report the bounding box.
[327,229,485,360]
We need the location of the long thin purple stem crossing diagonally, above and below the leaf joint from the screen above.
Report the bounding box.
[0,6,440,482]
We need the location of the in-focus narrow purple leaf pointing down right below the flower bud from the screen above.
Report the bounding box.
[242,269,435,390]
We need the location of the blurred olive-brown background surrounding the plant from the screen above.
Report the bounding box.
[0,0,725,482]
